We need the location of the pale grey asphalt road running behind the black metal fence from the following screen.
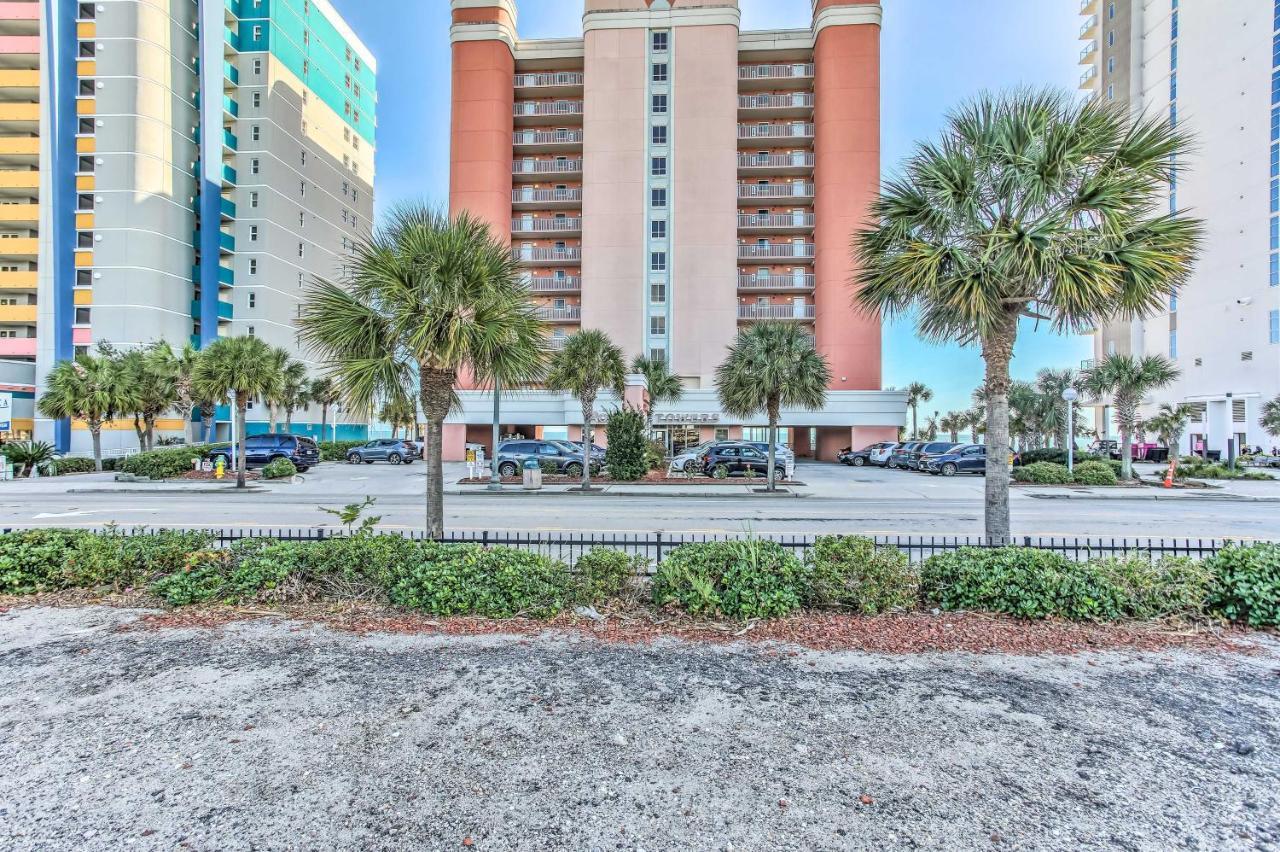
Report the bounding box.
[0,464,1280,539]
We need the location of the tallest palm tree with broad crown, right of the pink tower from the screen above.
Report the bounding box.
[854,91,1203,541]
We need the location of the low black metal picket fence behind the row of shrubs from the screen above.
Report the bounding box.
[0,527,1228,573]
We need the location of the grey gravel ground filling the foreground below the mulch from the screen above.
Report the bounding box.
[0,608,1280,851]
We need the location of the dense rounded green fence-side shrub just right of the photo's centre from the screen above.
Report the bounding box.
[653,539,806,619]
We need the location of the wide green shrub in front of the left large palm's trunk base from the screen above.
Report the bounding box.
[390,544,575,618]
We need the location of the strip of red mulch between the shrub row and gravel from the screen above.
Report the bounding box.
[97,596,1256,656]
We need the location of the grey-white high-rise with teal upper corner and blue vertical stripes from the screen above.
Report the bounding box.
[36,0,378,450]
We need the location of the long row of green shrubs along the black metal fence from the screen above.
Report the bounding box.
[0,530,1280,647]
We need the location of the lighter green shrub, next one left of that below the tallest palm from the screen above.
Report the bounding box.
[805,536,920,615]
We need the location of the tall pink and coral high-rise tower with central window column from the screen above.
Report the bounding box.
[445,0,905,459]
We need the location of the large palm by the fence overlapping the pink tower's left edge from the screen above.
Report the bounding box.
[298,205,545,539]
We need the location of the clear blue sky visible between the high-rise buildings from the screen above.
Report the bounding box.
[333,0,1092,413]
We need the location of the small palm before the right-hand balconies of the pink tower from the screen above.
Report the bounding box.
[716,322,831,491]
